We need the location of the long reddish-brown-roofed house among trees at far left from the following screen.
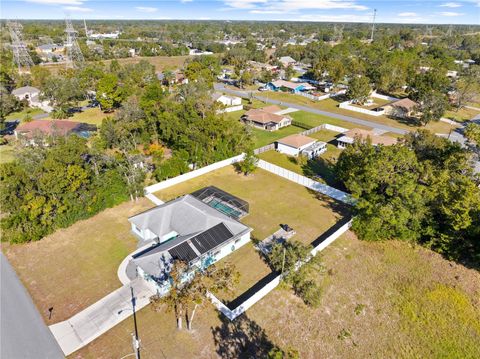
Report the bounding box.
[14,120,96,145]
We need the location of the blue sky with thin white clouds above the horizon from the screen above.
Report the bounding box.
[0,0,480,25]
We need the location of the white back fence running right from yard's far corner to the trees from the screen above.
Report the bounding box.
[257,160,353,204]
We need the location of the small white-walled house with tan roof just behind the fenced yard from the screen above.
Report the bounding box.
[275,134,327,158]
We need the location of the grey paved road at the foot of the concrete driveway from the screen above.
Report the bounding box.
[0,253,65,359]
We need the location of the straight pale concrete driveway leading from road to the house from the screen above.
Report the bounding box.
[50,278,155,355]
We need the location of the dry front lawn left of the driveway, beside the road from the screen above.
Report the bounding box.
[3,199,153,325]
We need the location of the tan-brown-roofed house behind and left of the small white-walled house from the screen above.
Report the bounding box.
[241,105,292,131]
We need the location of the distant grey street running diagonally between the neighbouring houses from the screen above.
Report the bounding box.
[215,84,408,135]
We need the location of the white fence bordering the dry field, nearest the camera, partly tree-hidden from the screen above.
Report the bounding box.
[207,220,352,320]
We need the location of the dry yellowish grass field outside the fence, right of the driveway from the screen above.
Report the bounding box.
[71,232,480,359]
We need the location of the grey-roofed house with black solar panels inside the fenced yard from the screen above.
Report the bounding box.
[127,193,252,290]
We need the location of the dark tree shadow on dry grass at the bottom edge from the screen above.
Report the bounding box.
[211,313,274,359]
